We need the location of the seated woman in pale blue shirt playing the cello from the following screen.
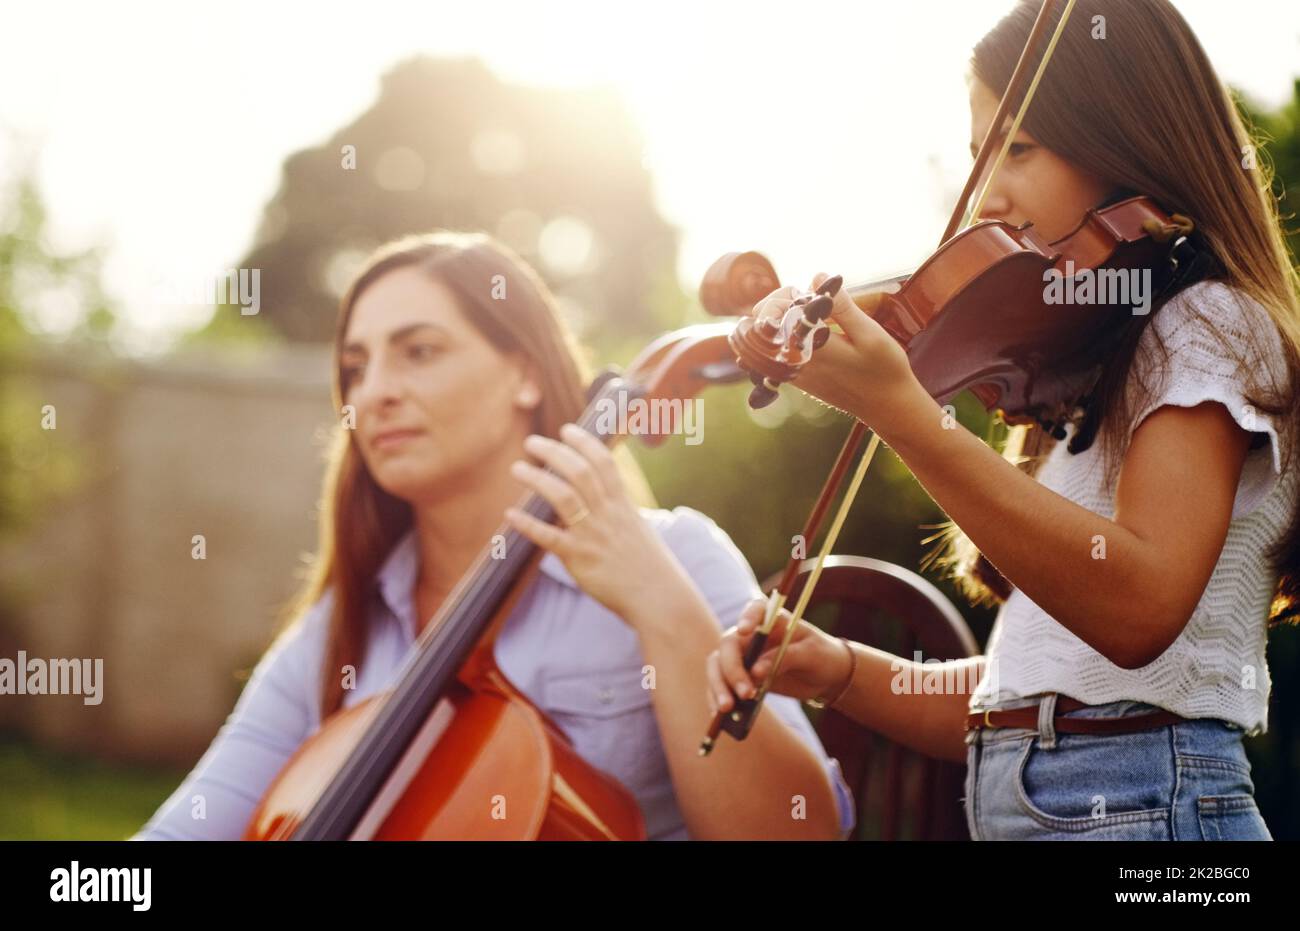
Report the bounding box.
[138,228,853,839]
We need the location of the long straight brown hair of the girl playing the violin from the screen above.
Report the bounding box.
[935,0,1300,625]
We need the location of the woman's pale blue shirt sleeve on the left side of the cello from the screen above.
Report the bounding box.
[131,593,333,840]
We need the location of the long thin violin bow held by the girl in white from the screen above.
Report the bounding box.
[699,0,1075,757]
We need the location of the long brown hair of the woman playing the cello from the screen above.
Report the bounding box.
[286,231,654,720]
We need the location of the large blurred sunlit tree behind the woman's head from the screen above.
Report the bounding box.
[202,56,677,341]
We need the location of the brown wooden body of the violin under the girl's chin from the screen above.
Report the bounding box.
[889,198,1170,419]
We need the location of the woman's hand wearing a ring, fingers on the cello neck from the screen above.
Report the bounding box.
[506,424,673,619]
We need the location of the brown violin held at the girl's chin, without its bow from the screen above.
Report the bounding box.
[699,196,1190,429]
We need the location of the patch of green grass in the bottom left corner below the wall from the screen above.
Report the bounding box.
[0,735,185,840]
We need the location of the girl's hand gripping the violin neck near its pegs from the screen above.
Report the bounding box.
[754,273,928,426]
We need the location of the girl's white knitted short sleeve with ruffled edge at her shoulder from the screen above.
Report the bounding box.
[1128,282,1287,520]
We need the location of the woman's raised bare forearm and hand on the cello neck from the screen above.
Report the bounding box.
[507,425,844,840]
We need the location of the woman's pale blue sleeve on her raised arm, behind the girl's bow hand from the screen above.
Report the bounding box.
[666,507,855,833]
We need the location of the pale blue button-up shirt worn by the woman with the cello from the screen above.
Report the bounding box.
[135,507,854,840]
